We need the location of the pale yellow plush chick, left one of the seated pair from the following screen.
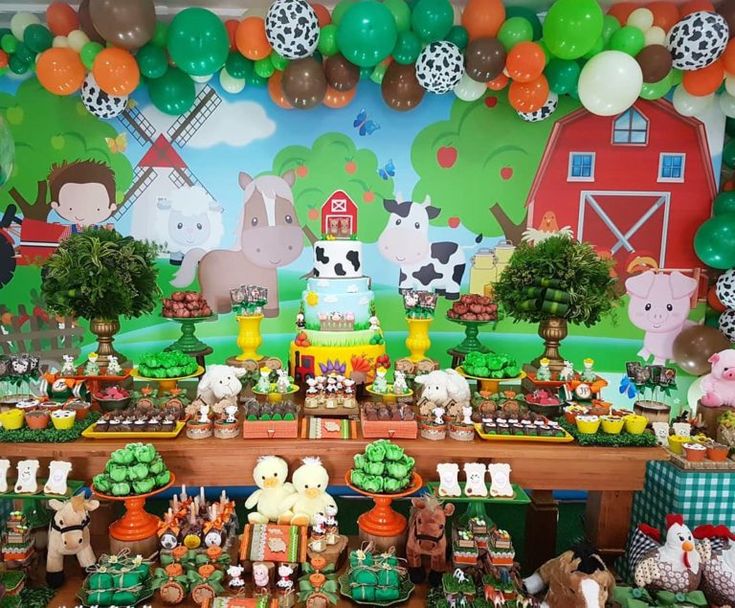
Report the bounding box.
[245,456,295,524]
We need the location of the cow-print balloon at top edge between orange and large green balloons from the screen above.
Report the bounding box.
[265,0,319,59]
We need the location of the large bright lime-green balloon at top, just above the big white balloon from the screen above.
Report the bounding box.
[544,0,603,59]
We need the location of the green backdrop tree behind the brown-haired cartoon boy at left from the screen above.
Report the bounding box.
[0,78,133,220]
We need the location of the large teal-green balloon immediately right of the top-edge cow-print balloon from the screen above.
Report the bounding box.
[337,0,396,67]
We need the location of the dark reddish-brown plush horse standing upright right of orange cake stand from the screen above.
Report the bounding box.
[406,494,454,585]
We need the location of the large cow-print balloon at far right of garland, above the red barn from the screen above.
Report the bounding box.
[666,11,730,71]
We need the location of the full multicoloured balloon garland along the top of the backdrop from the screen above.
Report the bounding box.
[0,0,735,122]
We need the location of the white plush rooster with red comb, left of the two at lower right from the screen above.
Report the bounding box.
[628,515,709,593]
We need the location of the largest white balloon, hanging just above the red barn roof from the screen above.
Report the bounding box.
[578,51,643,116]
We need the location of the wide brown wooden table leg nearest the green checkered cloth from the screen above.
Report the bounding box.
[585,491,633,562]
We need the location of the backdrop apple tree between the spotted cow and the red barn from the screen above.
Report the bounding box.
[411,92,575,243]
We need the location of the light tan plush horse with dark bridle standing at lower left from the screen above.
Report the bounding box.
[46,494,100,589]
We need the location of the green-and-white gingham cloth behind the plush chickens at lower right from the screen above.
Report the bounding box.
[616,461,735,578]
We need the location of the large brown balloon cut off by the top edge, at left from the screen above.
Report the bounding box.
[89,0,156,50]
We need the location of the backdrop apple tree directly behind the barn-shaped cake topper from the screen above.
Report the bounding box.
[273,133,393,242]
